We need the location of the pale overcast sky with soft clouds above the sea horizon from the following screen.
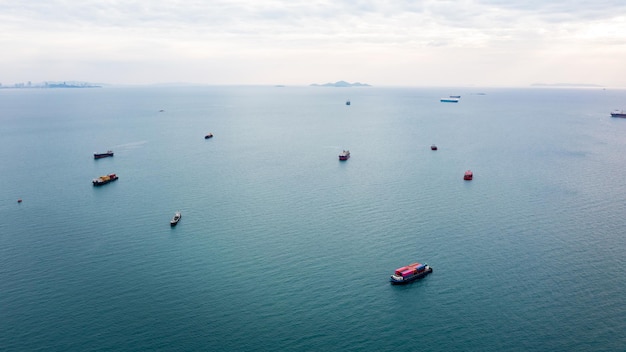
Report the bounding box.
[0,0,626,87]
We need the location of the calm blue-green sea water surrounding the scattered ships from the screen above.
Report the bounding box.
[0,86,626,351]
